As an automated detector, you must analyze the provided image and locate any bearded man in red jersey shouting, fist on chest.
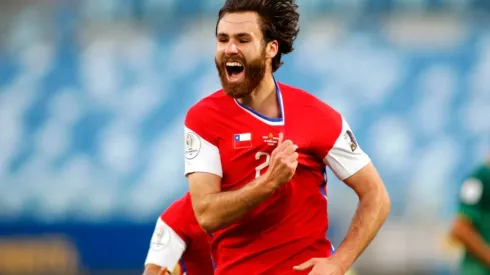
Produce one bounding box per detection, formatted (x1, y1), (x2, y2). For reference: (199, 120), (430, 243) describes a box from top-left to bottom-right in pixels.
(185, 0), (390, 275)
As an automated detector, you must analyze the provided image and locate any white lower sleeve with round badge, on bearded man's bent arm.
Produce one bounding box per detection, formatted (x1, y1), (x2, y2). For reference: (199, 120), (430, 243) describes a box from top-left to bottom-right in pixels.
(184, 127), (223, 177)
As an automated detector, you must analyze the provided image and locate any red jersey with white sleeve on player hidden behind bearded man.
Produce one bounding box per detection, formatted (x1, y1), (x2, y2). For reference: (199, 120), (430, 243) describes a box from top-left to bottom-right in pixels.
(145, 193), (214, 275)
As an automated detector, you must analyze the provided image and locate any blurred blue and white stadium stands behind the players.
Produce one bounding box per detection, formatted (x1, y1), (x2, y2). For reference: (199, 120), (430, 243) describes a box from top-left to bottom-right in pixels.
(0, 0), (490, 274)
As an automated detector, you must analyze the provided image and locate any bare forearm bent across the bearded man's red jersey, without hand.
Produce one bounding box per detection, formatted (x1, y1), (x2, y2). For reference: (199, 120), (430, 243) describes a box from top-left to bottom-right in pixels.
(196, 177), (274, 233)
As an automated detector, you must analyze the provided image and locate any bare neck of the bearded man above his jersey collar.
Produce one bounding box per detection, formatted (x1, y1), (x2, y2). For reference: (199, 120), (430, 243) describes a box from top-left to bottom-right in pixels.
(239, 74), (281, 118)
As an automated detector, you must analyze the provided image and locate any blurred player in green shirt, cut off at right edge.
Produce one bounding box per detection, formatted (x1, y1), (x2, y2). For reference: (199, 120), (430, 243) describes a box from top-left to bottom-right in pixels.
(451, 162), (490, 275)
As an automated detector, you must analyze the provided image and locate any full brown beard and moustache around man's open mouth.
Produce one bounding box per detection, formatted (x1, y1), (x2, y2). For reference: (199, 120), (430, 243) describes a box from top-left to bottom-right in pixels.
(214, 47), (266, 99)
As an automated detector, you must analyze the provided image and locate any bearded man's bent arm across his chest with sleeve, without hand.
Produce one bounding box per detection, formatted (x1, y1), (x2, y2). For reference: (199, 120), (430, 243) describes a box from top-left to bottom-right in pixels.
(184, 107), (274, 233)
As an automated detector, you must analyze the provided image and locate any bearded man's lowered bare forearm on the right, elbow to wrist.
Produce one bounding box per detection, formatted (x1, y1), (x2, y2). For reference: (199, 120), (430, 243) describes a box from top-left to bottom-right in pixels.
(332, 191), (390, 270)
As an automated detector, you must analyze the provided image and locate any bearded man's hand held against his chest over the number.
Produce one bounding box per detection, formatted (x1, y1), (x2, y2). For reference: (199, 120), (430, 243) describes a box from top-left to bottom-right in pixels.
(265, 133), (298, 189)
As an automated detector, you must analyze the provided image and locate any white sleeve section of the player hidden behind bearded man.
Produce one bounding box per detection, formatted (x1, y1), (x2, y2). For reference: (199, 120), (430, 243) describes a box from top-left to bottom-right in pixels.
(145, 218), (186, 270)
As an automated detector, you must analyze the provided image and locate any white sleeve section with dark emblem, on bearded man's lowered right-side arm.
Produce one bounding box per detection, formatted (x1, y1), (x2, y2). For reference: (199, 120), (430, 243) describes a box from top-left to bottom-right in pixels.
(323, 117), (371, 180)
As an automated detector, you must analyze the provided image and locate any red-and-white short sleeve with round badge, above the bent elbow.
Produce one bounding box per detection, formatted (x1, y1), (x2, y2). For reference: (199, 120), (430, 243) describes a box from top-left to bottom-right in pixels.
(184, 106), (223, 177)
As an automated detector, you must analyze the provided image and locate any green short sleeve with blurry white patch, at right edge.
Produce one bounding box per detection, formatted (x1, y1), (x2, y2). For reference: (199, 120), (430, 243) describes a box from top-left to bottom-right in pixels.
(459, 177), (484, 221)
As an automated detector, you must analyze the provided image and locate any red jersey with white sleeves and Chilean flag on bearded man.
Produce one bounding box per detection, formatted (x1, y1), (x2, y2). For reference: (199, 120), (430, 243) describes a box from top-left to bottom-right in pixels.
(185, 83), (370, 275)
